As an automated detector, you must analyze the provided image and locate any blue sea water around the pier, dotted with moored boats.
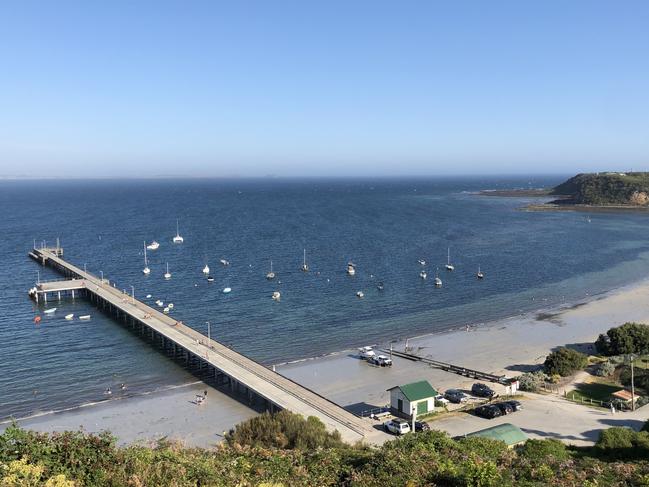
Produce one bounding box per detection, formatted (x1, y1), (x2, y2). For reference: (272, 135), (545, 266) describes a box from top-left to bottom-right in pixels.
(0, 177), (649, 418)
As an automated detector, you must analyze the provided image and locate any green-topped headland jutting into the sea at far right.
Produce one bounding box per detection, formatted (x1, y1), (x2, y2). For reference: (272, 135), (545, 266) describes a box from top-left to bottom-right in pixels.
(550, 172), (649, 207)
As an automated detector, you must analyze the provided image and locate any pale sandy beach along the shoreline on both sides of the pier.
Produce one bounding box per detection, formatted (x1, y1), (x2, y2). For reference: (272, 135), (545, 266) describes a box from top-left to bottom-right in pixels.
(7, 281), (649, 446)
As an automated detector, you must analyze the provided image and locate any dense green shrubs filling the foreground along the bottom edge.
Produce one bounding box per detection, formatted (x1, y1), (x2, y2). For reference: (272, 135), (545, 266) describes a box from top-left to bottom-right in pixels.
(0, 413), (649, 487)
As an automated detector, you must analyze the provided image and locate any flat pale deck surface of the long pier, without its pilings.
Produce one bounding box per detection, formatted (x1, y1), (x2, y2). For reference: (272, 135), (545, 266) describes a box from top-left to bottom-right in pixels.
(32, 249), (373, 442)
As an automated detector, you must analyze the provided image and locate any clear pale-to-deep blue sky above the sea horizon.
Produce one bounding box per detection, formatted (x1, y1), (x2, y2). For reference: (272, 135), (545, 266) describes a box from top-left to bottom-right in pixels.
(0, 0), (649, 176)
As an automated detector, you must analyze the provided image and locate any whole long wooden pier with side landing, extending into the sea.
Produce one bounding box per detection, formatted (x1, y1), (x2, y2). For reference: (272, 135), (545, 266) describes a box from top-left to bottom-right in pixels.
(29, 246), (372, 442)
